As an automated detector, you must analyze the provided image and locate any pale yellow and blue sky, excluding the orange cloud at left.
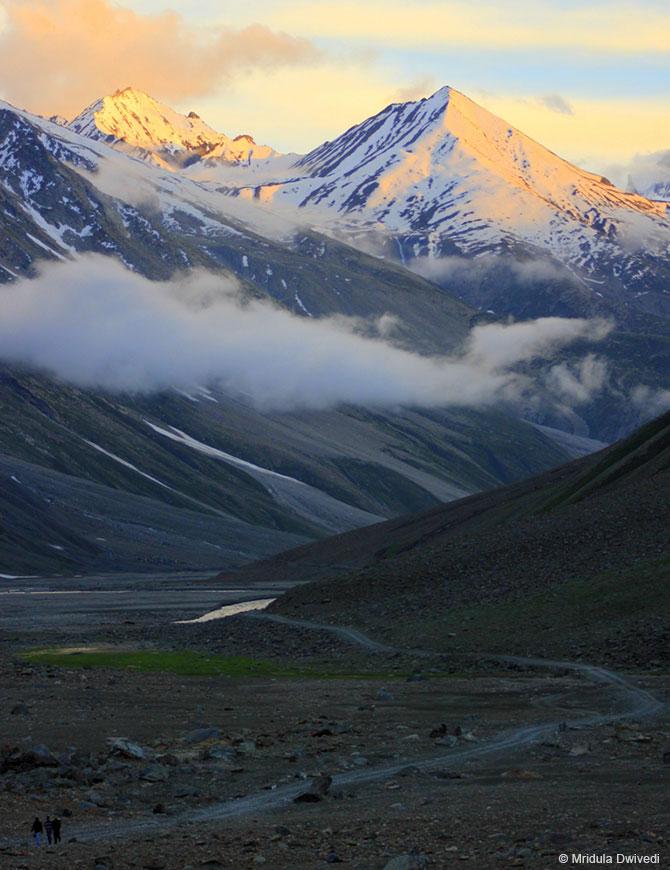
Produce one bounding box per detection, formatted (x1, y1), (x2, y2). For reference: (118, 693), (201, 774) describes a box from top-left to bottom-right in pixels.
(122, 0), (670, 169)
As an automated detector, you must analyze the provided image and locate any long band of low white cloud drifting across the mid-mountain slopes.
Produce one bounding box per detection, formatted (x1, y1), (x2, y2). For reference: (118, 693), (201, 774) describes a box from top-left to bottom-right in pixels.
(0, 255), (609, 409)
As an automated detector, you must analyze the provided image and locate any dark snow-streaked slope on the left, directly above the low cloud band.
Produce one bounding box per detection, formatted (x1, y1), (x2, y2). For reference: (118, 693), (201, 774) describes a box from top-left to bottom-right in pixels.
(0, 99), (475, 352)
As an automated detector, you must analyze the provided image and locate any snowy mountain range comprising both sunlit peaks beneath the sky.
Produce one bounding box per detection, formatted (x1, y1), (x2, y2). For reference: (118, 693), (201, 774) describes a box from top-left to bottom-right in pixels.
(8, 81), (670, 332)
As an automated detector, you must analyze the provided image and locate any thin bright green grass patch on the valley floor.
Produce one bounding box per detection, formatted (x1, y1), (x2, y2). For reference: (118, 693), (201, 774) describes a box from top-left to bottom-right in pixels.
(23, 648), (406, 680)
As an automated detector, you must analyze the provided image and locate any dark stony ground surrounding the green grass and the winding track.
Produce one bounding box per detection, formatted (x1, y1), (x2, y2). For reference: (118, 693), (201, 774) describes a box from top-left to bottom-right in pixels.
(0, 614), (670, 870)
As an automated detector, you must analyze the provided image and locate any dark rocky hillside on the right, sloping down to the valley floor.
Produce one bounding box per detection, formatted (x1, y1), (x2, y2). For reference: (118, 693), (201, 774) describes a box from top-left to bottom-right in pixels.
(231, 414), (670, 662)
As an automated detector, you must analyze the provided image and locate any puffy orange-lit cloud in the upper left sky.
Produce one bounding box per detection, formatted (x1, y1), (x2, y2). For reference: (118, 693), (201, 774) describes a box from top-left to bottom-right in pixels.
(0, 0), (319, 117)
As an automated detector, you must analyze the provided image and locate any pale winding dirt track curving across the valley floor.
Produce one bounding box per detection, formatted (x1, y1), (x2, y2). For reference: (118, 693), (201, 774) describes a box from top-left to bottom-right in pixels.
(31, 612), (665, 841)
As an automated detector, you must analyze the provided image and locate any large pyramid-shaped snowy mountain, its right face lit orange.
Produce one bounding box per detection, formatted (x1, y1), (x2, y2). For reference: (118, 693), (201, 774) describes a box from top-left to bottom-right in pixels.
(219, 87), (670, 304)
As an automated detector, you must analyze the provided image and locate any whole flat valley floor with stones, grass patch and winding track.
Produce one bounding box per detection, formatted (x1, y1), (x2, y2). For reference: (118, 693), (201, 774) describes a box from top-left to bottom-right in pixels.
(0, 575), (670, 870)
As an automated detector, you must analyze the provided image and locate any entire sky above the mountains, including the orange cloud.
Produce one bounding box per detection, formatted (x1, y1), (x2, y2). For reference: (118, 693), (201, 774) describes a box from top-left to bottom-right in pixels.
(0, 0), (670, 172)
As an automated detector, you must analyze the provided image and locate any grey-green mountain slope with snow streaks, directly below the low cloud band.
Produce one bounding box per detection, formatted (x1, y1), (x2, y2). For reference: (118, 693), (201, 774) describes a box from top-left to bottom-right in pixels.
(0, 367), (566, 574)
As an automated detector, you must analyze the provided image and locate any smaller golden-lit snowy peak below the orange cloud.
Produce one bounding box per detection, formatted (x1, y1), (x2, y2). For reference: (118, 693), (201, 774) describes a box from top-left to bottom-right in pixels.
(69, 87), (275, 168)
